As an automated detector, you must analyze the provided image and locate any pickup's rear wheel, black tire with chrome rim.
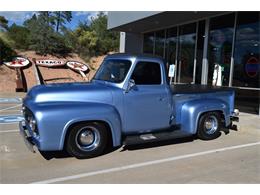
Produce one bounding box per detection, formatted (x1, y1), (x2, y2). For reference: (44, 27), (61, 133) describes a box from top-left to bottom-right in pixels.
(197, 112), (221, 140)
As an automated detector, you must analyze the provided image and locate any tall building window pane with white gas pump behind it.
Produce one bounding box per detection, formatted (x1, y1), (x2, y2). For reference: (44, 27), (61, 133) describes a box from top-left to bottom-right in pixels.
(208, 13), (235, 86)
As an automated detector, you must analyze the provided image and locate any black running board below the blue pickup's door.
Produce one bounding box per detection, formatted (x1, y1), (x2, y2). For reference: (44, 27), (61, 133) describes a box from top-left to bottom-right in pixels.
(123, 130), (187, 145)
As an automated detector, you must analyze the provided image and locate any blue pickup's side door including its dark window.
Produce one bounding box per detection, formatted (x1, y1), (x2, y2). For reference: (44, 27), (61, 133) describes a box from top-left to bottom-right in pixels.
(124, 61), (171, 133)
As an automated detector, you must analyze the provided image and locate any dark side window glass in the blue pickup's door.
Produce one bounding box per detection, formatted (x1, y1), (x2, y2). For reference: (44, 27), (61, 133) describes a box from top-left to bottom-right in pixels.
(131, 61), (162, 85)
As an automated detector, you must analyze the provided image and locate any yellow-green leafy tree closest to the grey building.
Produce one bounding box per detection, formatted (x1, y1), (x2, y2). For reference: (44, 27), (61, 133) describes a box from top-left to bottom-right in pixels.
(63, 12), (119, 60)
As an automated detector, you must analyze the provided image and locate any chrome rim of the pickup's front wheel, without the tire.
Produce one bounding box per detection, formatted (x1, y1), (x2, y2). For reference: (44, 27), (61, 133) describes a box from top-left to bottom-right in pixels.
(75, 126), (100, 151)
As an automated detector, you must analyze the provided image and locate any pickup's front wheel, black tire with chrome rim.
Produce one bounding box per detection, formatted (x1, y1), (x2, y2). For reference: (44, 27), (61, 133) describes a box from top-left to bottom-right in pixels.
(66, 122), (108, 159)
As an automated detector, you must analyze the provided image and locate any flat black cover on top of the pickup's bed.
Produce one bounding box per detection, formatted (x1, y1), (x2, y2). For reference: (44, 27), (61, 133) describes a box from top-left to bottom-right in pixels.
(170, 84), (232, 95)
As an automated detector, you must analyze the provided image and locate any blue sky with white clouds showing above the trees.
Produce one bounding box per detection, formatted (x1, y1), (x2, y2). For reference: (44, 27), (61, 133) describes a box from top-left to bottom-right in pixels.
(0, 11), (103, 30)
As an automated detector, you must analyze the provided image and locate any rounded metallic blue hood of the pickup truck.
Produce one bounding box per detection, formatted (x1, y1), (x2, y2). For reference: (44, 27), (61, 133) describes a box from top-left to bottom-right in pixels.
(26, 82), (112, 104)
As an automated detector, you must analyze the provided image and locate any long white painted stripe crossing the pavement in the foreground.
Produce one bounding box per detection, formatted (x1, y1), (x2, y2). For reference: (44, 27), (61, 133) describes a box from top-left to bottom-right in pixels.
(33, 141), (260, 184)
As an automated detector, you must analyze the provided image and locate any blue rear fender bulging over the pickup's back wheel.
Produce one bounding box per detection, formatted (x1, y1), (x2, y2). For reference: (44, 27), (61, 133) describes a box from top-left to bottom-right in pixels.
(181, 99), (230, 134)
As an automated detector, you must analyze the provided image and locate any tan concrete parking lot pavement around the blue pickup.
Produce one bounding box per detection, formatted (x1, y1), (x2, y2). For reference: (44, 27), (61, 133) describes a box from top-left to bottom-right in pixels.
(0, 93), (260, 183)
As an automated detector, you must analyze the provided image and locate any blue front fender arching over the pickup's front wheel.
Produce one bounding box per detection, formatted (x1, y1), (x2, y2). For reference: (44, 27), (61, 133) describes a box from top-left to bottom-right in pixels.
(31, 102), (121, 151)
